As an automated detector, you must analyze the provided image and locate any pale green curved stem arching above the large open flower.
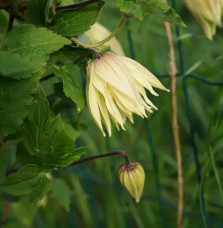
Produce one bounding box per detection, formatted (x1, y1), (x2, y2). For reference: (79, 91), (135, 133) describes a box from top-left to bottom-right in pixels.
(70, 14), (129, 48)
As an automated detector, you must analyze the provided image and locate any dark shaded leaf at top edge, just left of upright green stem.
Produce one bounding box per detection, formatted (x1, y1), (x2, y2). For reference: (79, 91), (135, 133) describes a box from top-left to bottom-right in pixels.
(25, 0), (47, 26)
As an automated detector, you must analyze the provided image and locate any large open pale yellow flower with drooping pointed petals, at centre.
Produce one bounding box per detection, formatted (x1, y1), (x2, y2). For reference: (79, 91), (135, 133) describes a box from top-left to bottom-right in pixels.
(86, 52), (168, 136)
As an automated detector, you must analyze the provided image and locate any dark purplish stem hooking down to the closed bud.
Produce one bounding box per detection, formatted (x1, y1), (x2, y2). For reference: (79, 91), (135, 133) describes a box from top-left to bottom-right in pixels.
(70, 150), (130, 166)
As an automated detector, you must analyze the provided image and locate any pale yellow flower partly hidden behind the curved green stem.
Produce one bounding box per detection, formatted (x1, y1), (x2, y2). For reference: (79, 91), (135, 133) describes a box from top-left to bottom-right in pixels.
(86, 22), (125, 56)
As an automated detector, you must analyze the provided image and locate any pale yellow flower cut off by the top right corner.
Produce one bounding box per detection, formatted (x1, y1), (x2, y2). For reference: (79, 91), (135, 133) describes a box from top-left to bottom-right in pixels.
(186, 0), (223, 40)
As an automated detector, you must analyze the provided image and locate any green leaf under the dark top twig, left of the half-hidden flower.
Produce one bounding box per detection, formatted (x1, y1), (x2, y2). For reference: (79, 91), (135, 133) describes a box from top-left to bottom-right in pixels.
(50, 1), (104, 36)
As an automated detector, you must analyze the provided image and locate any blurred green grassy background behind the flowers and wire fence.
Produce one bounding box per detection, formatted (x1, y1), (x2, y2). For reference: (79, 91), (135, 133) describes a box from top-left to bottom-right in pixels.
(0, 0), (223, 228)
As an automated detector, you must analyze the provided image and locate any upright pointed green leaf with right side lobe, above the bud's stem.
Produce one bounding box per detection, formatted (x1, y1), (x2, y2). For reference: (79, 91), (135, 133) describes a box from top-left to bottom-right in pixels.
(23, 88), (61, 157)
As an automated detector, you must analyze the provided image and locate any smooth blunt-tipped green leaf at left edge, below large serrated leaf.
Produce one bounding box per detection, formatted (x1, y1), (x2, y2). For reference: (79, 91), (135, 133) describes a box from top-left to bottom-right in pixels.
(0, 51), (38, 79)
